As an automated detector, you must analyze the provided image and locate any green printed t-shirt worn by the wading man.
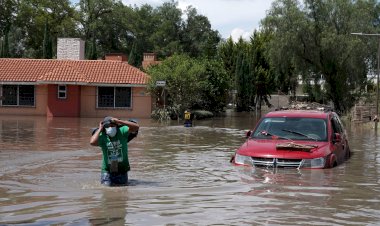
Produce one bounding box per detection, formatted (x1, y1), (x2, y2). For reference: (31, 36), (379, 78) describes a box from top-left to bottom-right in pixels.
(98, 126), (130, 174)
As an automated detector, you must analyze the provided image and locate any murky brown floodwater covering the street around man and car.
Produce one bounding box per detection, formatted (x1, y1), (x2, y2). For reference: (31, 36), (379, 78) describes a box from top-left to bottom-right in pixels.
(0, 112), (380, 225)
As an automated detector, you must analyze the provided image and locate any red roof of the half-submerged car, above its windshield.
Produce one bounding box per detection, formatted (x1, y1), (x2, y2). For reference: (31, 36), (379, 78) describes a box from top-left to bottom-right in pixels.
(265, 110), (331, 119)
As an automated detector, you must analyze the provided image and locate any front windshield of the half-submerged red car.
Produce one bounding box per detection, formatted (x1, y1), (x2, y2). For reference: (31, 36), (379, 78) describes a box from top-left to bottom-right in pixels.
(252, 117), (327, 141)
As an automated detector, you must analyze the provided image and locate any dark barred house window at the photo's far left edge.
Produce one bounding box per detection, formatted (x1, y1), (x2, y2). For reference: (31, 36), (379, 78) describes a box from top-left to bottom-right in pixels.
(2, 85), (35, 106)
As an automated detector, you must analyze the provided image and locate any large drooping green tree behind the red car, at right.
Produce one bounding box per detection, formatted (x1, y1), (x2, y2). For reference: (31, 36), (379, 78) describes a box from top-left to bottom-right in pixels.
(263, 0), (378, 112)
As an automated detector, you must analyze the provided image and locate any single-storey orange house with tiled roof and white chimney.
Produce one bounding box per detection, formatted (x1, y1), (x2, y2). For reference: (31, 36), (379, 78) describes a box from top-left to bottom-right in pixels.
(0, 39), (156, 118)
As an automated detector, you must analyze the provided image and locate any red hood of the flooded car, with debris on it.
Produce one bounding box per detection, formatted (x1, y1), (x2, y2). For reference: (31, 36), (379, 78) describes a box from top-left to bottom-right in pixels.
(237, 139), (329, 159)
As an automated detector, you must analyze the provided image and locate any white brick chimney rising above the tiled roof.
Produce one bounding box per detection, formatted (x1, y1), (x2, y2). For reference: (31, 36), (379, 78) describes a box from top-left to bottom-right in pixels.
(57, 38), (84, 60)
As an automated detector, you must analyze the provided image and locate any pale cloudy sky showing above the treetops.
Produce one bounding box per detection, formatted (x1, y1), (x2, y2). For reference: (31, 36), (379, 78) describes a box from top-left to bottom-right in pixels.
(123, 0), (274, 40)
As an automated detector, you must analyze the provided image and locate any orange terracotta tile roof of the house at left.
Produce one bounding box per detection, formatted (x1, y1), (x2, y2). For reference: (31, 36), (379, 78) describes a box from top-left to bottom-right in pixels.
(0, 58), (148, 85)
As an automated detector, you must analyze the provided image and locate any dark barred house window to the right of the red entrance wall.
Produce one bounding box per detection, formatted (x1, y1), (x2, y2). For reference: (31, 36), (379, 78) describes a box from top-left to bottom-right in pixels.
(98, 87), (132, 108)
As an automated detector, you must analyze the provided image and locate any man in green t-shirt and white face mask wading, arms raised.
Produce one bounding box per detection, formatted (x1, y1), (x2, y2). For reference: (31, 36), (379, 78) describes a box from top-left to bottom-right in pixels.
(90, 117), (139, 186)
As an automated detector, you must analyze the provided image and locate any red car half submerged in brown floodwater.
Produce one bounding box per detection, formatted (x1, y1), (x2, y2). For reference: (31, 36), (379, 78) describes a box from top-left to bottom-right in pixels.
(231, 110), (350, 169)
